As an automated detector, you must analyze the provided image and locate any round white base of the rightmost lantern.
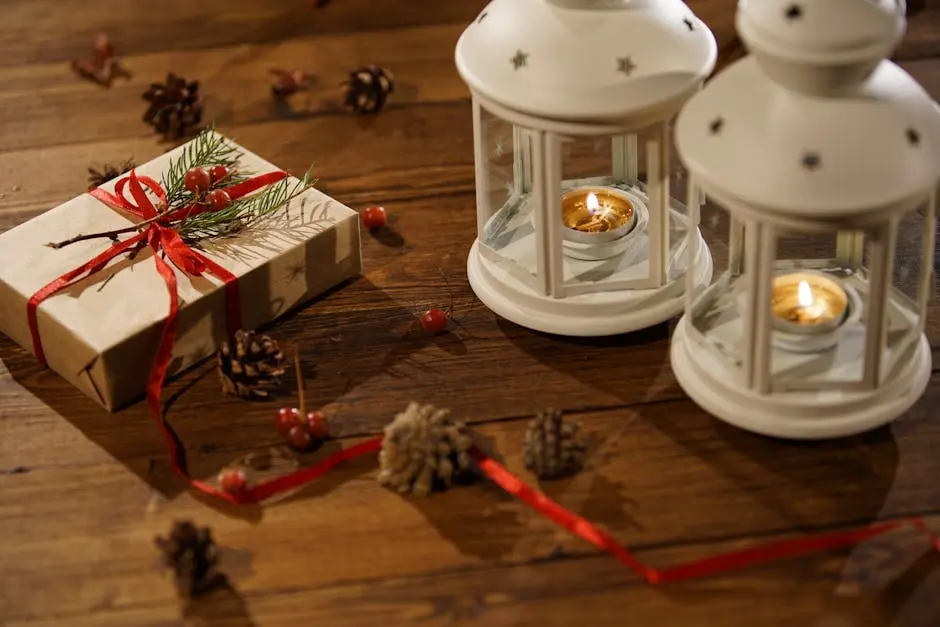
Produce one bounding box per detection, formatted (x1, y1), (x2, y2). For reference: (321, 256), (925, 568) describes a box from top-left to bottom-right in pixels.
(670, 316), (931, 440)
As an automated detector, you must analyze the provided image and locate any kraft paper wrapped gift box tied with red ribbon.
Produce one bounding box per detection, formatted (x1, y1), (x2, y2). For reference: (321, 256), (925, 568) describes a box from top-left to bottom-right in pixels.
(0, 132), (362, 411)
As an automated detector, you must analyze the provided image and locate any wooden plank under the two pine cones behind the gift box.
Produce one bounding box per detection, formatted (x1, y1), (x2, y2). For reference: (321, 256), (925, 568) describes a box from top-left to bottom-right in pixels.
(0, 23), (469, 151)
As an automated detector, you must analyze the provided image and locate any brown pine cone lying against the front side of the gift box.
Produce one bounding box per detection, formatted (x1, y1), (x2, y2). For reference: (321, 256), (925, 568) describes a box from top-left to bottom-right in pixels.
(217, 331), (284, 399)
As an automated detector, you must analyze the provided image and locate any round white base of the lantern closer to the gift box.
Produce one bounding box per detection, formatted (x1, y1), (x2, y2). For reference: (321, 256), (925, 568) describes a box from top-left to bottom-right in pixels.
(467, 233), (713, 337)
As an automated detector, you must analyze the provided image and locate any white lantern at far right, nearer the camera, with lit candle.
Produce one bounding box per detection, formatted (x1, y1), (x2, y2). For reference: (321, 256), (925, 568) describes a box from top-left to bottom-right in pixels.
(671, 0), (940, 439)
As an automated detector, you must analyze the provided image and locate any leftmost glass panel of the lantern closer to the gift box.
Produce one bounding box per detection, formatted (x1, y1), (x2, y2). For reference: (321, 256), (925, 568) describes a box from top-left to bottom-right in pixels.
(477, 107), (540, 285)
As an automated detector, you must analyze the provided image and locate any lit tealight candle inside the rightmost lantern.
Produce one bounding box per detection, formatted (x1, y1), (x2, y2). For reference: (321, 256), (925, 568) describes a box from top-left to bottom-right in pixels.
(771, 272), (849, 334)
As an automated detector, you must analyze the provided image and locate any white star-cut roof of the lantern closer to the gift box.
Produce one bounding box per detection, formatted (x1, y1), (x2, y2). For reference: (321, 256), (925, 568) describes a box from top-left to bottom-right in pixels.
(455, 0), (717, 121)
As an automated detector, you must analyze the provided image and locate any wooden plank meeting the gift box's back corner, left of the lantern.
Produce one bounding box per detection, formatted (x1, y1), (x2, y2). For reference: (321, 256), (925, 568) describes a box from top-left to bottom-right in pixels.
(0, 101), (474, 230)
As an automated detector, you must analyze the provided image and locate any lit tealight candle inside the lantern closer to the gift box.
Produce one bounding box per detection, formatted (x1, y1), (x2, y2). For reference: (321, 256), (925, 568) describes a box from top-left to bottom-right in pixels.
(561, 187), (636, 244)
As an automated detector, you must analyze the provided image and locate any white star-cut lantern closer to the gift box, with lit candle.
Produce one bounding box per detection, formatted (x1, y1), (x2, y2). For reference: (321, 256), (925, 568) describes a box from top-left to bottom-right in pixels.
(456, 0), (717, 336)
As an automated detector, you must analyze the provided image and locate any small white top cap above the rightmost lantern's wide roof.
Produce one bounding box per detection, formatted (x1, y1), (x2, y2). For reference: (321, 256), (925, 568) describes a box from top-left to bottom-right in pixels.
(736, 0), (906, 58)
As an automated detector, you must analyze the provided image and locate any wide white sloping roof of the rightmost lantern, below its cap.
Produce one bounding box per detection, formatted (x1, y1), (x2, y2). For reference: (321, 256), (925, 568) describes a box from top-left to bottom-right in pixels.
(676, 56), (940, 217)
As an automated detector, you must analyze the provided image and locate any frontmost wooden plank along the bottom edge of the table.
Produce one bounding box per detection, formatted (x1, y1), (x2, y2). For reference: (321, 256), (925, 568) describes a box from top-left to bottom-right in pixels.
(10, 524), (940, 627)
